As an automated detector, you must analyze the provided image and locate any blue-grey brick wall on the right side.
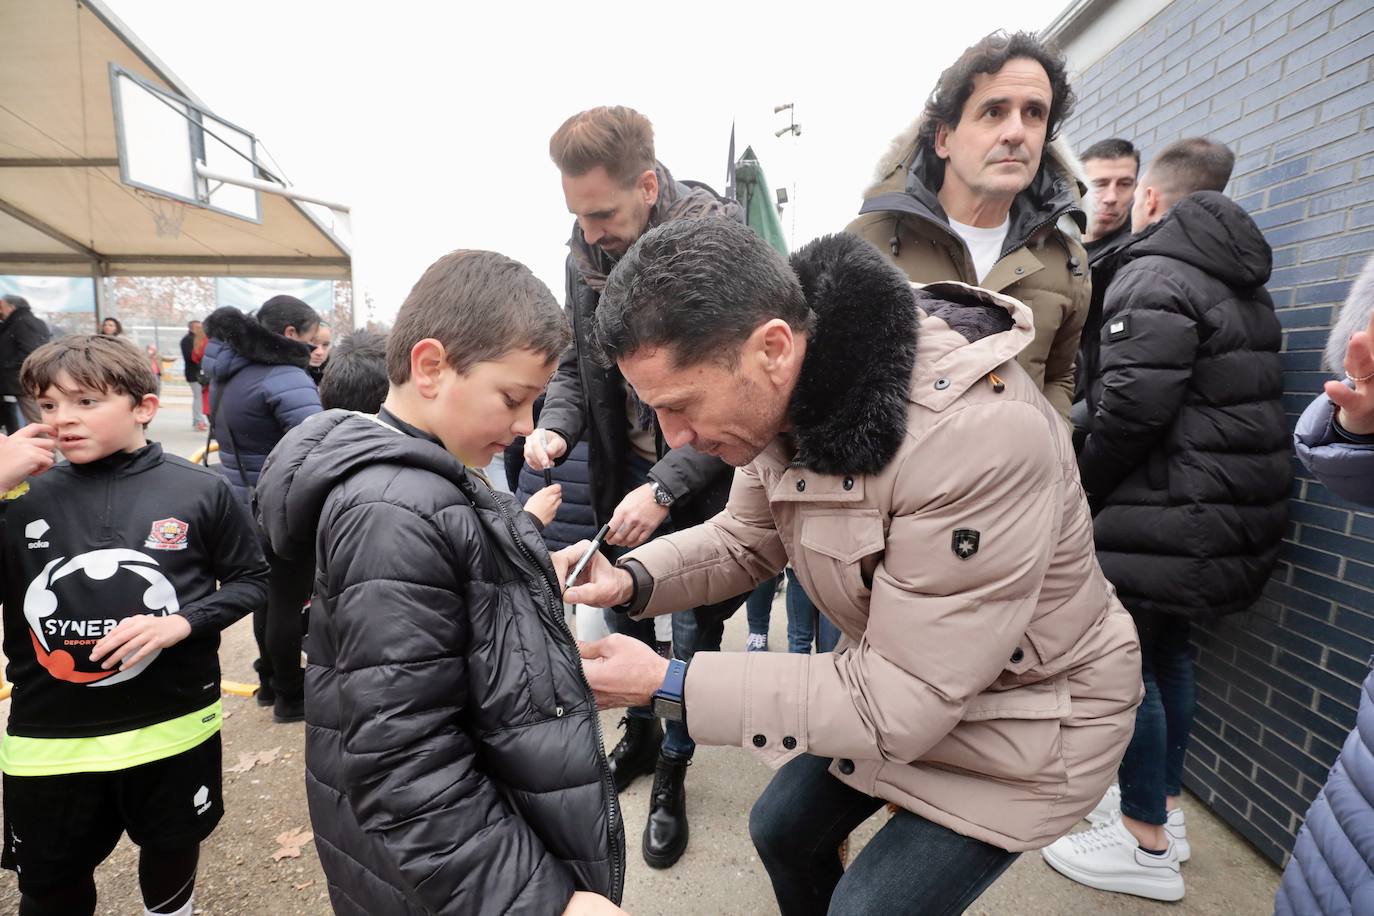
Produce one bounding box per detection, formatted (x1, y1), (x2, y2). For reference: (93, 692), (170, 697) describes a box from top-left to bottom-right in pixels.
(1068, 0), (1374, 862)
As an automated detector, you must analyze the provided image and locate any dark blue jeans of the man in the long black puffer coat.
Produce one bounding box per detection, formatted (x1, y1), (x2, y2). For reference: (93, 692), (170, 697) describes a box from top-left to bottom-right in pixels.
(1117, 614), (1198, 824)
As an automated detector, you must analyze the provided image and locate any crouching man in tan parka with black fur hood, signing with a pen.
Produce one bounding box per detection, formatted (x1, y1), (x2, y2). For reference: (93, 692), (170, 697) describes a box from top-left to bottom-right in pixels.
(554, 218), (1143, 916)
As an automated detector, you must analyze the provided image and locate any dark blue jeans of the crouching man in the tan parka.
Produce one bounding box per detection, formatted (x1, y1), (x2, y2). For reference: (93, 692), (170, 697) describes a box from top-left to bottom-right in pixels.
(749, 754), (1017, 916)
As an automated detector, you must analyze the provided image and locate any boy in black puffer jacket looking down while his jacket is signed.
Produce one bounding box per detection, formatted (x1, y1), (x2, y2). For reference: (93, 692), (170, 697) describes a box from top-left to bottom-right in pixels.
(257, 251), (625, 915)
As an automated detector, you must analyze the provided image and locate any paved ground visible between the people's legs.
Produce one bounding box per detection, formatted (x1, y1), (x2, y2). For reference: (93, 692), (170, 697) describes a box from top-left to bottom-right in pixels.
(0, 385), (1278, 916)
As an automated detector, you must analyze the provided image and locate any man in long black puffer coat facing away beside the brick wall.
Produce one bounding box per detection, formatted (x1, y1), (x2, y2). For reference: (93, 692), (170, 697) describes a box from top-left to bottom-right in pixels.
(1044, 137), (1293, 901)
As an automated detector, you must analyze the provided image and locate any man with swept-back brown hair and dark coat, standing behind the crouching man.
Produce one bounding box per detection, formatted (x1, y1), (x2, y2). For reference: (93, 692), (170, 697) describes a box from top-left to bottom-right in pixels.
(525, 106), (752, 868)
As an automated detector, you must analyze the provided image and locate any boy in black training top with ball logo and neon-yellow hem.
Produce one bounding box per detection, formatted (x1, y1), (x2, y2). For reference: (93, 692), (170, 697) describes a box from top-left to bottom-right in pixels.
(0, 335), (267, 916)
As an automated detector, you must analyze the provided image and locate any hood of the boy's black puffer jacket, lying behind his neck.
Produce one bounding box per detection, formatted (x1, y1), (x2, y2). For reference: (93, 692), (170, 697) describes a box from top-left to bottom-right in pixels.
(257, 411), (478, 559)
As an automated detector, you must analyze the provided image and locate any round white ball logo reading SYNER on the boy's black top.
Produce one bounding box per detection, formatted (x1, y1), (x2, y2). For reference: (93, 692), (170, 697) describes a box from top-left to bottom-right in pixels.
(23, 548), (181, 687)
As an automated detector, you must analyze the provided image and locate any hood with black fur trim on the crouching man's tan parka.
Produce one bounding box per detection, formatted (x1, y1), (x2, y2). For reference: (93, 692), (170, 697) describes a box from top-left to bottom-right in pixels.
(787, 232), (1013, 474)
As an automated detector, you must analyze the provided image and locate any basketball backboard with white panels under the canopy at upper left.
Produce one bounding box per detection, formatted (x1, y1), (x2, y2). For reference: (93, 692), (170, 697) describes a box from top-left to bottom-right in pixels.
(110, 63), (262, 223)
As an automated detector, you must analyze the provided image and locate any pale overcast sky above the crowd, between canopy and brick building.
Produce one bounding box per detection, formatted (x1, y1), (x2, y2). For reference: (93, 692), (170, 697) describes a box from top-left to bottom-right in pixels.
(107, 0), (1066, 319)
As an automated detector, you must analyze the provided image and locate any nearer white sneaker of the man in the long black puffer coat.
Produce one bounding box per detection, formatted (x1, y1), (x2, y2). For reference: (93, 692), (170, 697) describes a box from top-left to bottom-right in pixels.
(1040, 818), (1183, 901)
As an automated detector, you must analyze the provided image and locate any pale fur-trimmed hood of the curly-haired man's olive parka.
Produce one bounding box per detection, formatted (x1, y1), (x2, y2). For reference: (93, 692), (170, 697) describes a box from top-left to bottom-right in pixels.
(860, 117), (1092, 240)
